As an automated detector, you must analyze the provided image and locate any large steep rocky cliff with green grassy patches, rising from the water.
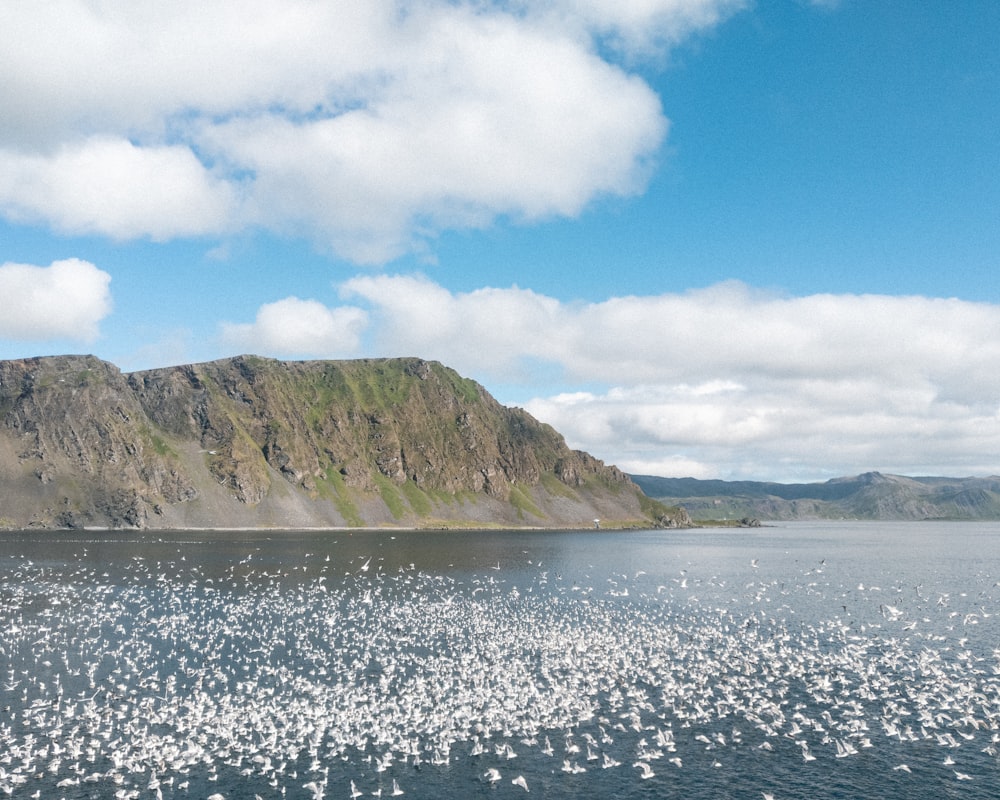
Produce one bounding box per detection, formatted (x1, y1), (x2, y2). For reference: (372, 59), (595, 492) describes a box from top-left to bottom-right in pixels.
(0, 356), (687, 528)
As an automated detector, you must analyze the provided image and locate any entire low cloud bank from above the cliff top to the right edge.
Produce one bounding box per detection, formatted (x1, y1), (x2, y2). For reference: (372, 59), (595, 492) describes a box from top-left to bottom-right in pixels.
(233, 275), (1000, 480)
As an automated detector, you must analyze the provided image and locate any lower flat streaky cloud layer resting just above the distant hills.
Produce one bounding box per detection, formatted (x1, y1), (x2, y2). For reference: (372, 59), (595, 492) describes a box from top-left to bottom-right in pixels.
(526, 380), (1000, 480)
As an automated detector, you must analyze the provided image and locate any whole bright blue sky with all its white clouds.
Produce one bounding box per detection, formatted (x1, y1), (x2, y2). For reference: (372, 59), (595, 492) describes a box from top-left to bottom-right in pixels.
(0, 0), (1000, 482)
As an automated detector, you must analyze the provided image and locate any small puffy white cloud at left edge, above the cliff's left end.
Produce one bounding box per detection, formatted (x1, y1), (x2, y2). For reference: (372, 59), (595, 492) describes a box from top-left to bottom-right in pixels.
(0, 258), (111, 342)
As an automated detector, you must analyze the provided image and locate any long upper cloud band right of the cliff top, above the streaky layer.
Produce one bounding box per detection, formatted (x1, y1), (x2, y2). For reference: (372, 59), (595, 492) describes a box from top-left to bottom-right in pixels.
(341, 275), (1000, 390)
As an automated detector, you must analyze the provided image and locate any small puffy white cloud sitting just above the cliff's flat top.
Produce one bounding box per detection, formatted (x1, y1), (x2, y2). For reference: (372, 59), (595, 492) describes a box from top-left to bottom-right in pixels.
(222, 297), (368, 358)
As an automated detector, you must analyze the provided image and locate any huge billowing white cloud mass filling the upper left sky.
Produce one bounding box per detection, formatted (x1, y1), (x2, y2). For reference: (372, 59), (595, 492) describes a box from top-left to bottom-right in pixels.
(0, 0), (740, 262)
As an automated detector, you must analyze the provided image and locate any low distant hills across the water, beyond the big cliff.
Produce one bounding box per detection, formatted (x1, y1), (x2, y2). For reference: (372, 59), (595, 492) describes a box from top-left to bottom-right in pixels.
(631, 472), (1000, 520)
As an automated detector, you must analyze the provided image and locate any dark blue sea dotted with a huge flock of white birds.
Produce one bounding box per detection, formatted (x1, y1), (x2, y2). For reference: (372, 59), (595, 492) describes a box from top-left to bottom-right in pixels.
(0, 521), (1000, 800)
